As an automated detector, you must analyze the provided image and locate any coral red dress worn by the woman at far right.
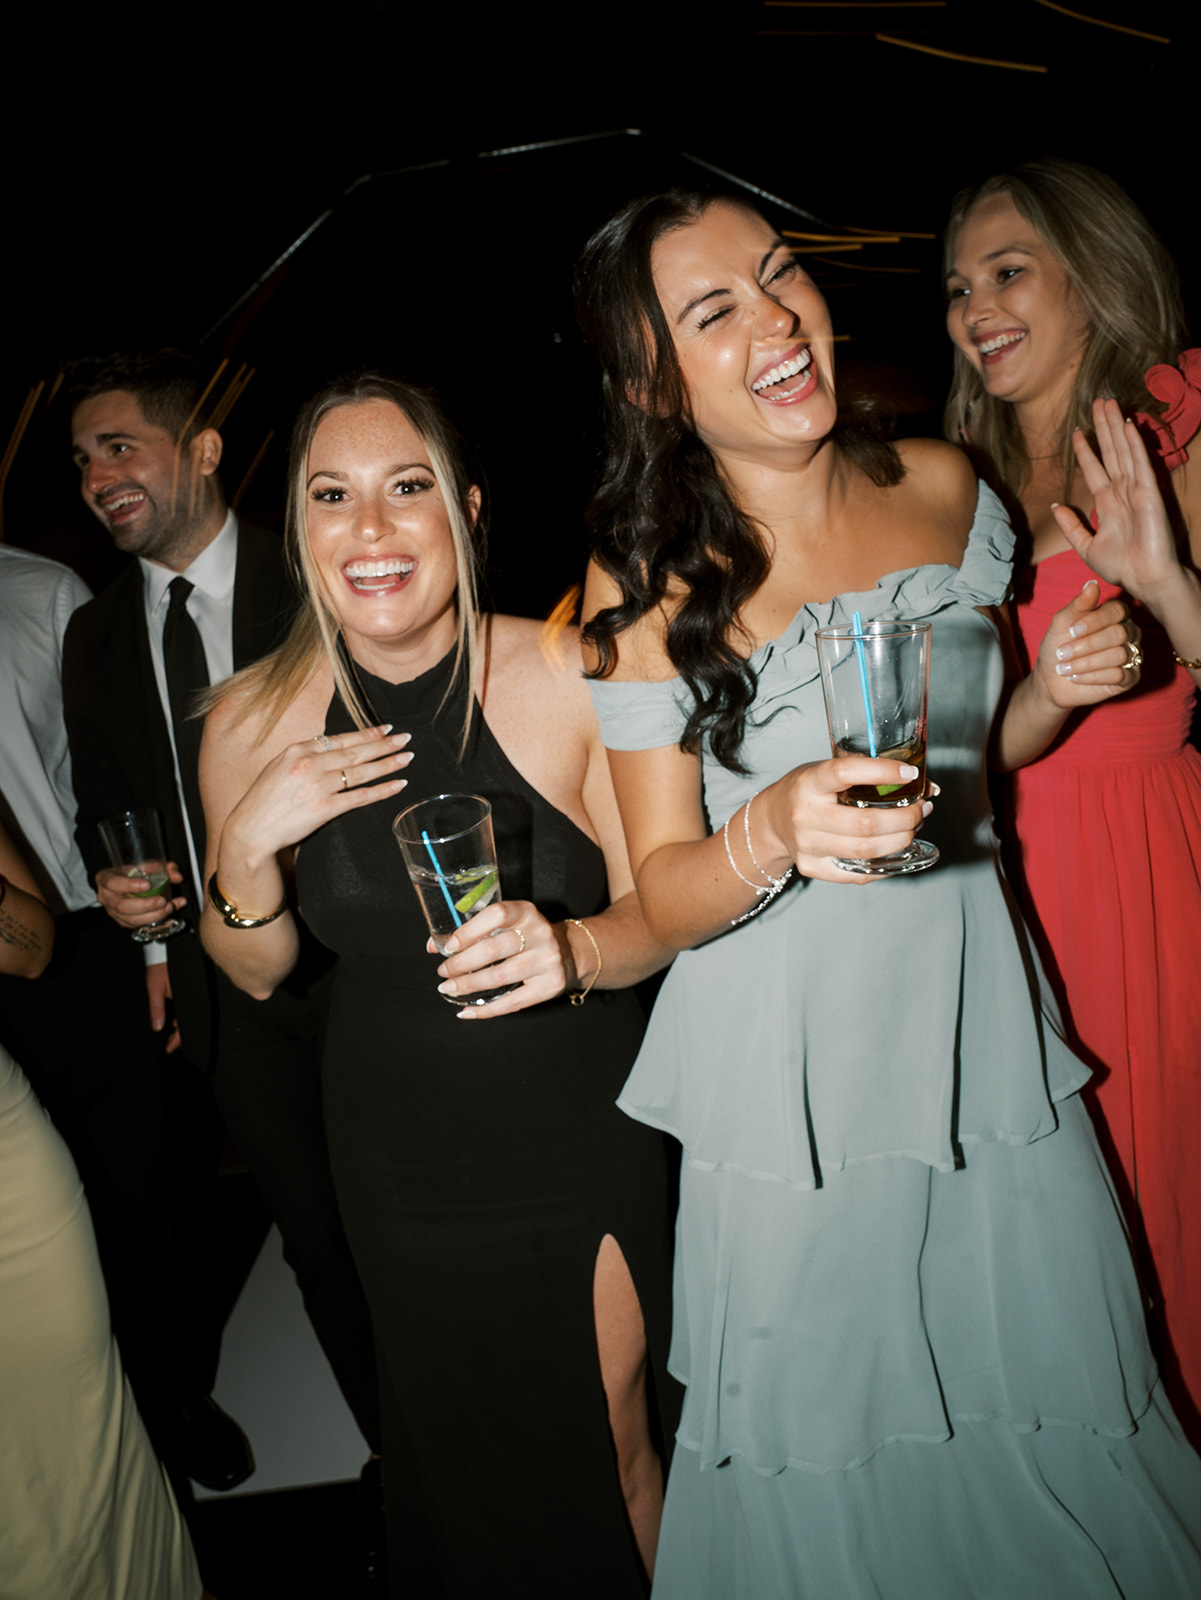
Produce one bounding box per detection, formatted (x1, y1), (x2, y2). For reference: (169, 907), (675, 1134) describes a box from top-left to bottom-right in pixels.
(1012, 368), (1201, 1442)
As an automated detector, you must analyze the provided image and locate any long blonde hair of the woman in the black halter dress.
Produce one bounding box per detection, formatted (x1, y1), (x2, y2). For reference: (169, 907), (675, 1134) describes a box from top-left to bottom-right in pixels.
(215, 371), (483, 746)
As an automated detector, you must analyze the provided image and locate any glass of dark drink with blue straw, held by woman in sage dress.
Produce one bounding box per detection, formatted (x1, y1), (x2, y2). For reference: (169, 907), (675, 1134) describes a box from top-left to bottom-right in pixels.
(817, 622), (939, 877)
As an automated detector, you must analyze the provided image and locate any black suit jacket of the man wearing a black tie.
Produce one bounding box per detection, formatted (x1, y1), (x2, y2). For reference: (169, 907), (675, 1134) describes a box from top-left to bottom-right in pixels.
(62, 522), (296, 1070)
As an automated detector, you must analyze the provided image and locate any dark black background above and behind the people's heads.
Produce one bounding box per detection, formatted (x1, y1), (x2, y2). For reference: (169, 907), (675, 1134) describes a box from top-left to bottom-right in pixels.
(0, 0), (1196, 614)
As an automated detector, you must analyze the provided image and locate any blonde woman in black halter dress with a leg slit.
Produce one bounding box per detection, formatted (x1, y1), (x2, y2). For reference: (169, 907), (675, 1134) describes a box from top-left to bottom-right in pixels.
(201, 378), (681, 1600)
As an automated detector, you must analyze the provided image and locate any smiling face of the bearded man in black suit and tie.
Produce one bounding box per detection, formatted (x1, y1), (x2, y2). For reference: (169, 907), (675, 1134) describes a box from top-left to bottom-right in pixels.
(70, 389), (225, 573)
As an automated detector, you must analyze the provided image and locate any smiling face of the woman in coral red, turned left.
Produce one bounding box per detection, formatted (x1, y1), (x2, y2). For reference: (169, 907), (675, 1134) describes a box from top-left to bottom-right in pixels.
(947, 194), (1089, 416)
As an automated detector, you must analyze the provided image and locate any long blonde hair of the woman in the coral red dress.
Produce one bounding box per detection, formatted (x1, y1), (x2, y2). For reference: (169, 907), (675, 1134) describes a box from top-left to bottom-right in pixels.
(944, 157), (1185, 499)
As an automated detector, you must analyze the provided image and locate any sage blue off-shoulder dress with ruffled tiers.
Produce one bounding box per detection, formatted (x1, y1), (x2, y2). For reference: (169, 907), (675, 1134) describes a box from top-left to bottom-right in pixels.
(593, 486), (1201, 1600)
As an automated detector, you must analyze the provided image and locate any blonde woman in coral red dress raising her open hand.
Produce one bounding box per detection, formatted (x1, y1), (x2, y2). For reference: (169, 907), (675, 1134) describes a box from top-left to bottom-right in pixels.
(947, 160), (1201, 1442)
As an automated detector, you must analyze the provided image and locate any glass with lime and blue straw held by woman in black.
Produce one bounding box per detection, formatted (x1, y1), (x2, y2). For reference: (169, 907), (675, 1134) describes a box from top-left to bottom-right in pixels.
(392, 795), (520, 1005)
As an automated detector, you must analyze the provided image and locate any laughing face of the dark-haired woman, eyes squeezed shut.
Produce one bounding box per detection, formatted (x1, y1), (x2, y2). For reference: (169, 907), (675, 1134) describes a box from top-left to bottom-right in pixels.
(651, 202), (836, 470)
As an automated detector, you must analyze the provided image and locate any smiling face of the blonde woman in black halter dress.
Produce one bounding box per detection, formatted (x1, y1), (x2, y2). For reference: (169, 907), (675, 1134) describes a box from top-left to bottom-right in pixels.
(304, 400), (480, 682)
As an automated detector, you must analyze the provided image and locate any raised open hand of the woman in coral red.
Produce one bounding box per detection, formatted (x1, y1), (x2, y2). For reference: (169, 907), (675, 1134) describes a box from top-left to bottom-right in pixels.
(1052, 400), (1180, 603)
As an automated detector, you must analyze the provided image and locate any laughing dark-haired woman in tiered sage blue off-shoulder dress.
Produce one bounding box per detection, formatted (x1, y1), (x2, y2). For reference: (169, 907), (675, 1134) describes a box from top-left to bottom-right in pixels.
(577, 194), (1201, 1600)
